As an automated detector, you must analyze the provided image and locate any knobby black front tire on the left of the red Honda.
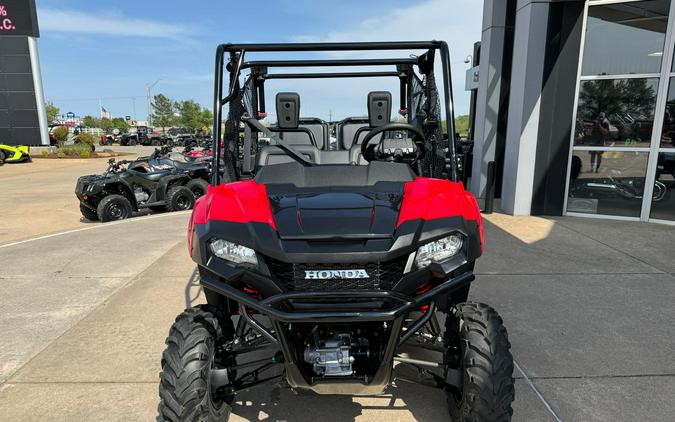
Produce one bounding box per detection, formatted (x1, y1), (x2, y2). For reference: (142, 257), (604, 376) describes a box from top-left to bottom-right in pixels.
(158, 305), (234, 422)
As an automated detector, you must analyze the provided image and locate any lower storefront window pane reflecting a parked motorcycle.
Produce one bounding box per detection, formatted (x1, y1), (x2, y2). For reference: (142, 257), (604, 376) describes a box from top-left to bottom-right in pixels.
(567, 150), (649, 217)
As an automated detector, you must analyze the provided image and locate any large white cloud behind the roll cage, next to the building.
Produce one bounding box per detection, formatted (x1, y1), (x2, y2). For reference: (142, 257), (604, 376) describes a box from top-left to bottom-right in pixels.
(282, 0), (483, 117)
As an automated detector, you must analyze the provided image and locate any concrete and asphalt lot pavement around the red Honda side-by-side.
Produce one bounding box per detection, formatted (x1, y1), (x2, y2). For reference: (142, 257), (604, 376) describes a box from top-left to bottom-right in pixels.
(0, 156), (675, 421)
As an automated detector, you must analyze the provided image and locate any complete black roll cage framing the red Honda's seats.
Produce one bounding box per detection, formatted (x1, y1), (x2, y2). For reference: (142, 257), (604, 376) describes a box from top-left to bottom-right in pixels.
(212, 41), (458, 186)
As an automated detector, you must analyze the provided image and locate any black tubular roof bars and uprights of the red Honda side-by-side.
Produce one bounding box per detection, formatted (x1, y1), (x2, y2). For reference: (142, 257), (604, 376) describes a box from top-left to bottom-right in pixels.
(213, 41), (458, 185)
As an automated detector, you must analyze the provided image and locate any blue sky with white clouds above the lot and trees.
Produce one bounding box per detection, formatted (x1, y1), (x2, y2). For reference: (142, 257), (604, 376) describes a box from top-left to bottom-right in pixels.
(37, 0), (483, 120)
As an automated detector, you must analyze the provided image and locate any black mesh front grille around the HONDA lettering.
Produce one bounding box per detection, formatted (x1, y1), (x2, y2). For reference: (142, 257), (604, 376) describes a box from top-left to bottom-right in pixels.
(265, 256), (408, 292)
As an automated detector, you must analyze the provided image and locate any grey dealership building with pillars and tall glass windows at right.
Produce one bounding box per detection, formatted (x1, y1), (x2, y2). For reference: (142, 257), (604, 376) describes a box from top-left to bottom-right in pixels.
(471, 0), (675, 224)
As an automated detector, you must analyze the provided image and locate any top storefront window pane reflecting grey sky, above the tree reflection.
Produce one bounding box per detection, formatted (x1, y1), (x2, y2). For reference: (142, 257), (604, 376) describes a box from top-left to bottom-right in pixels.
(581, 0), (670, 76)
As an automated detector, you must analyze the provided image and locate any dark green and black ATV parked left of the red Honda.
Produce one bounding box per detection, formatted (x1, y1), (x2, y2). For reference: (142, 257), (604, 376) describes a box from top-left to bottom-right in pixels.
(75, 158), (195, 222)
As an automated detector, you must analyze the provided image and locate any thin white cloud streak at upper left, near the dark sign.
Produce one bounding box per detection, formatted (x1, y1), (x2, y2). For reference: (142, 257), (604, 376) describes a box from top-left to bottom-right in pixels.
(38, 7), (188, 39)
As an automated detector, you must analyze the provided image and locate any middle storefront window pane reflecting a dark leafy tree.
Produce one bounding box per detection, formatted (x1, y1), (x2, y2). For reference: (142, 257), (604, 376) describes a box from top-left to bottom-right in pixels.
(574, 78), (658, 148)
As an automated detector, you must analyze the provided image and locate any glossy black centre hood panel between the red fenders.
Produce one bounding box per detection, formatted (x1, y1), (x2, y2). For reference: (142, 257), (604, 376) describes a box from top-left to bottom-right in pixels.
(268, 182), (403, 240)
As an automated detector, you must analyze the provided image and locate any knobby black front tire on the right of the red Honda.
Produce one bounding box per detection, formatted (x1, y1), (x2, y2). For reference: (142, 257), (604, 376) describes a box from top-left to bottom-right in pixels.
(445, 302), (515, 422)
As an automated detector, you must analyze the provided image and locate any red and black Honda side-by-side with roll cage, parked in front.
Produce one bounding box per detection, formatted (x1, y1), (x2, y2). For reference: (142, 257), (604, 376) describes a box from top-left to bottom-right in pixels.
(159, 41), (514, 421)
